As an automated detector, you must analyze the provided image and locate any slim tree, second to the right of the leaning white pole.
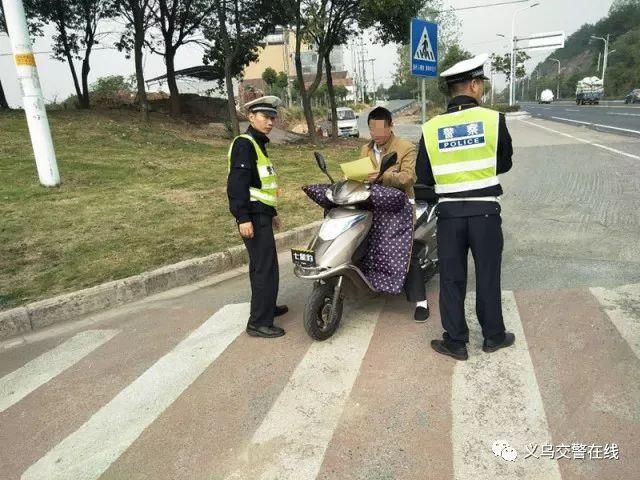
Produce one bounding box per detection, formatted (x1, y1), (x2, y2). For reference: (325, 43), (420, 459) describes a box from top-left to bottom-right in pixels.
(114, 0), (157, 122)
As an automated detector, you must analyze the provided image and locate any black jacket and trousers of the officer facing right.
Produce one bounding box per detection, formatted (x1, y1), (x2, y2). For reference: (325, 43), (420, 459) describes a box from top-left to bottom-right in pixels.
(227, 126), (280, 327)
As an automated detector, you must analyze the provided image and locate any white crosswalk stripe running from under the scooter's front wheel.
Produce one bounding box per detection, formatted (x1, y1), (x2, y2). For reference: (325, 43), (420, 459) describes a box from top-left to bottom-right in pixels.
(228, 301), (382, 480)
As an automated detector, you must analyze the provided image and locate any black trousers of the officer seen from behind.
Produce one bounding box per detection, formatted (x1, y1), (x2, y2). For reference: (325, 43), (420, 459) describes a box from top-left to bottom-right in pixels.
(437, 214), (505, 342)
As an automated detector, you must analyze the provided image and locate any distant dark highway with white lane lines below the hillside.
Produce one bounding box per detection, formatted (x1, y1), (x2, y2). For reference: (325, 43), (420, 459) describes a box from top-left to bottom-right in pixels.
(522, 102), (640, 136)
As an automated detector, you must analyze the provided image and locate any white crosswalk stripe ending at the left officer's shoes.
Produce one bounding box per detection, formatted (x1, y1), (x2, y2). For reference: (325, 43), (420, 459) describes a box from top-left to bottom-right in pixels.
(22, 304), (249, 480)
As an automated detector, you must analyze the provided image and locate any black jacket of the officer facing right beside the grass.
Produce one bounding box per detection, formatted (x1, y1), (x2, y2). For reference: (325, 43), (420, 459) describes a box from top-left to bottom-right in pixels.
(227, 126), (278, 223)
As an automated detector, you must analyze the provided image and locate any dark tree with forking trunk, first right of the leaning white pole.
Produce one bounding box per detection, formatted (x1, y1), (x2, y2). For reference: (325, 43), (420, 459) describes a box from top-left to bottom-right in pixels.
(29, 0), (115, 108)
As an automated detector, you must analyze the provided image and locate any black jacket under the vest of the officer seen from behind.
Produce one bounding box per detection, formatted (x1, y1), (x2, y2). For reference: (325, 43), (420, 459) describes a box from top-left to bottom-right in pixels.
(416, 95), (513, 216)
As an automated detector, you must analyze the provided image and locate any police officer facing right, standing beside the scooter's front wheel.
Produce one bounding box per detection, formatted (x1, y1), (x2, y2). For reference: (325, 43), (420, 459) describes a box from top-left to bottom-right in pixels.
(227, 96), (289, 338)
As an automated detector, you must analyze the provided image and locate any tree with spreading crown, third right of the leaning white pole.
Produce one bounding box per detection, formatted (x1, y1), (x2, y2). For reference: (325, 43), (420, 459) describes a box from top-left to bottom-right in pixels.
(147, 0), (219, 116)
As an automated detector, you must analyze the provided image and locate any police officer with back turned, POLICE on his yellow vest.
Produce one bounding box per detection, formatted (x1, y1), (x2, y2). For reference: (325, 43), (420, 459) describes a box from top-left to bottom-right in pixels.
(416, 54), (515, 360)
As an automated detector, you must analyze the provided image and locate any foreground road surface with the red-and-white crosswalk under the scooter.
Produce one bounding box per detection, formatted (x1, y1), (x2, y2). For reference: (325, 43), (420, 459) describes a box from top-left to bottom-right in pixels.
(0, 117), (640, 480)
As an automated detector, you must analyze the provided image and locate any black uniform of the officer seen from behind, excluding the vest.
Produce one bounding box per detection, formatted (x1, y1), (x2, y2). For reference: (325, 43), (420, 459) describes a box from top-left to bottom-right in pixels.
(416, 95), (513, 345)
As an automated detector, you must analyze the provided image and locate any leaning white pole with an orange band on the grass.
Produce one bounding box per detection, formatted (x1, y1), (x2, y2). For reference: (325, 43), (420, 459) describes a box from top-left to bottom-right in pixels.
(3, 0), (60, 187)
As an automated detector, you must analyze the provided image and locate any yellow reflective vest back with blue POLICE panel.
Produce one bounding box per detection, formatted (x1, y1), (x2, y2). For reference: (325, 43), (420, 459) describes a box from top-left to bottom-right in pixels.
(422, 107), (500, 195)
